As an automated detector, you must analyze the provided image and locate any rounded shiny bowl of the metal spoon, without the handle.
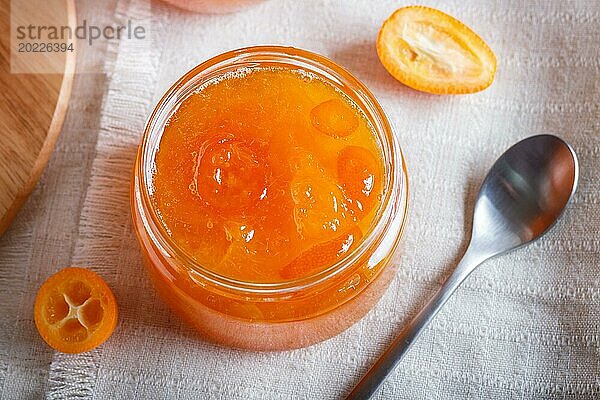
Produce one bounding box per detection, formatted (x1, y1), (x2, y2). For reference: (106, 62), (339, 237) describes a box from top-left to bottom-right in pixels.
(471, 135), (579, 257)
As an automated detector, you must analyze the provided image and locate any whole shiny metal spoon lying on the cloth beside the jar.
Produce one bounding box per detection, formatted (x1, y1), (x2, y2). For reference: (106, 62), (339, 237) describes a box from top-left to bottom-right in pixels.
(347, 135), (579, 400)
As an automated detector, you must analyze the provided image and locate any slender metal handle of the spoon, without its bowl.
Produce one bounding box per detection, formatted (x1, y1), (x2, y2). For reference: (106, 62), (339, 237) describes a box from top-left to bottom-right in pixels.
(346, 249), (484, 400)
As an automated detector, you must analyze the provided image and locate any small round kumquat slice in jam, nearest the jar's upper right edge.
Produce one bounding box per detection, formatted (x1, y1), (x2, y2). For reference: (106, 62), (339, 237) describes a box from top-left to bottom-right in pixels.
(310, 99), (359, 137)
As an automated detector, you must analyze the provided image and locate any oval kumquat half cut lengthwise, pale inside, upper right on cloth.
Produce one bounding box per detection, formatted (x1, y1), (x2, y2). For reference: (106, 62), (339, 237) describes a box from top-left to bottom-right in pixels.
(377, 6), (496, 94)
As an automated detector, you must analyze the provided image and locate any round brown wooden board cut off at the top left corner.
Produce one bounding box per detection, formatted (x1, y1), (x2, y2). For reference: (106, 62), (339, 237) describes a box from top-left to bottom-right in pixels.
(0, 0), (76, 235)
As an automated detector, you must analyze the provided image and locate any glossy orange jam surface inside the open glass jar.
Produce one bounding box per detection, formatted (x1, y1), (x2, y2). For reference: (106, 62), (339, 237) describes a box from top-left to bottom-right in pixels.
(151, 67), (384, 283)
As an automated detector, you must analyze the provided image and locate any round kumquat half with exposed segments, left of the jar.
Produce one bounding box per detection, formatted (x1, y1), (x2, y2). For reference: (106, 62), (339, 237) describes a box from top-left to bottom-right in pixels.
(33, 267), (117, 353)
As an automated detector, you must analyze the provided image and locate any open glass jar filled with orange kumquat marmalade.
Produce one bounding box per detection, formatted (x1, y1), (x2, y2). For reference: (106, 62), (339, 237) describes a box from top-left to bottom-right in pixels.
(131, 46), (408, 350)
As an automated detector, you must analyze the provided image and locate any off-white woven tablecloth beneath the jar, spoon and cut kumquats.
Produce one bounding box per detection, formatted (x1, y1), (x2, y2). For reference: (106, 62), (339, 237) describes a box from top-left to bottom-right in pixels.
(0, 0), (600, 399)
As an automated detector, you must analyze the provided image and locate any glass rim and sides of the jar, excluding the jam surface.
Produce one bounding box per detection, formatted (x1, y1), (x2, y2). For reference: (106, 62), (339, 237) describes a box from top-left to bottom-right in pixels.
(131, 46), (408, 350)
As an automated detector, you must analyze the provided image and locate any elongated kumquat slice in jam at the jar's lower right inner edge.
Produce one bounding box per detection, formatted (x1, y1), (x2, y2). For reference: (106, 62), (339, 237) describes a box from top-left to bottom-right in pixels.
(280, 227), (362, 279)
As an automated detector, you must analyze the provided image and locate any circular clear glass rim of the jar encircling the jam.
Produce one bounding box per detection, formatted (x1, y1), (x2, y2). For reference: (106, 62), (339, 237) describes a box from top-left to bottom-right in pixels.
(134, 46), (407, 294)
